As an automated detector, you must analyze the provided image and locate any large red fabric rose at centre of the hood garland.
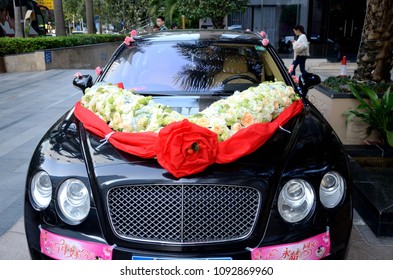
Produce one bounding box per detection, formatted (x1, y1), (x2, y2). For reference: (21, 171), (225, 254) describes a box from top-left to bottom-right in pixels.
(155, 120), (218, 178)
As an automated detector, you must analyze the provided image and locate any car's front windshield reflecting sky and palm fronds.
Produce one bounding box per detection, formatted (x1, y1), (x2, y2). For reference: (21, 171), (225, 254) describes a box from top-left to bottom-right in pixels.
(102, 41), (284, 95)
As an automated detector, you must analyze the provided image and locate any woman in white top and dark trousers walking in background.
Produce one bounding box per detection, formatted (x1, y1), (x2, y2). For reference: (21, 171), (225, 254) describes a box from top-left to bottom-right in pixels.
(288, 25), (310, 76)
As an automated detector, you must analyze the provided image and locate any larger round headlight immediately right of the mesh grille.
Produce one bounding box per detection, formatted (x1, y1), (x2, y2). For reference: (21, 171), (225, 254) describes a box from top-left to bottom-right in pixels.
(278, 179), (314, 223)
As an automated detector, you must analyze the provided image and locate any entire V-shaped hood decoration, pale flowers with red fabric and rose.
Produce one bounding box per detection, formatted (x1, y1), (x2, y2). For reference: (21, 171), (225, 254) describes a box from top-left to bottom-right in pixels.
(74, 82), (303, 178)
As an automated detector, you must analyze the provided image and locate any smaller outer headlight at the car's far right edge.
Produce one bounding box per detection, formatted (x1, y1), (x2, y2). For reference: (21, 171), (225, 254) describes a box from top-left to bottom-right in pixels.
(319, 171), (345, 208)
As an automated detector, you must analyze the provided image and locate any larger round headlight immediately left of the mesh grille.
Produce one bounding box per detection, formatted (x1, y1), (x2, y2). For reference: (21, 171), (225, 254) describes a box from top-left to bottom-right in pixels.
(57, 179), (90, 225)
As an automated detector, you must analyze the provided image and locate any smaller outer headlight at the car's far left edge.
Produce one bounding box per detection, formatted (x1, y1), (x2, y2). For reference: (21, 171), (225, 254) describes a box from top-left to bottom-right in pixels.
(30, 171), (52, 210)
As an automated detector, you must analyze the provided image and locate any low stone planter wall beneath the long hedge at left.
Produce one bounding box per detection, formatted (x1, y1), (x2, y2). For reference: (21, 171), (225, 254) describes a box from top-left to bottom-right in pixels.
(0, 42), (121, 72)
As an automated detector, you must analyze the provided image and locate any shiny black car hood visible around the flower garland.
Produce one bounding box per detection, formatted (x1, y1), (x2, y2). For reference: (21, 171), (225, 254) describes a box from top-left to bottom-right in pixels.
(77, 96), (302, 185)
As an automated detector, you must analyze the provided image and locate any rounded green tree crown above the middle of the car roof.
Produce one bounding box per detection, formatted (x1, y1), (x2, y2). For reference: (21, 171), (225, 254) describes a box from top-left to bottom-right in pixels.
(177, 0), (249, 29)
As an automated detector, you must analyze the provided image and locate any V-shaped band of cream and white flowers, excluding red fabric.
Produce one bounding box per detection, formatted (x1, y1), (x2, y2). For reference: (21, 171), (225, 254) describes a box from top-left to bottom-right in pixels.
(81, 82), (299, 142)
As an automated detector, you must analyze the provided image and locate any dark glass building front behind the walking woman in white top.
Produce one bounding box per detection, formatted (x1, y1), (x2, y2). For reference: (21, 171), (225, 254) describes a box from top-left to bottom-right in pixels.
(228, 0), (367, 60)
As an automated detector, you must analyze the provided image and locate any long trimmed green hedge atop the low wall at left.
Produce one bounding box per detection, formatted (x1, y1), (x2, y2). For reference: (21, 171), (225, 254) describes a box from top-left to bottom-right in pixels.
(0, 34), (125, 55)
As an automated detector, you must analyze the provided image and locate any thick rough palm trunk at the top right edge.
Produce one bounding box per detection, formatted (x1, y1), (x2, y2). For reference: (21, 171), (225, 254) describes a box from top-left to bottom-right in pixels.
(354, 0), (393, 82)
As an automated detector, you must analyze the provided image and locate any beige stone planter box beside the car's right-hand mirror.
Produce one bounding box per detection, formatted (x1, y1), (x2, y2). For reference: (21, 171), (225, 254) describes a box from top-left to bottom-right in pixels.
(307, 85), (378, 145)
